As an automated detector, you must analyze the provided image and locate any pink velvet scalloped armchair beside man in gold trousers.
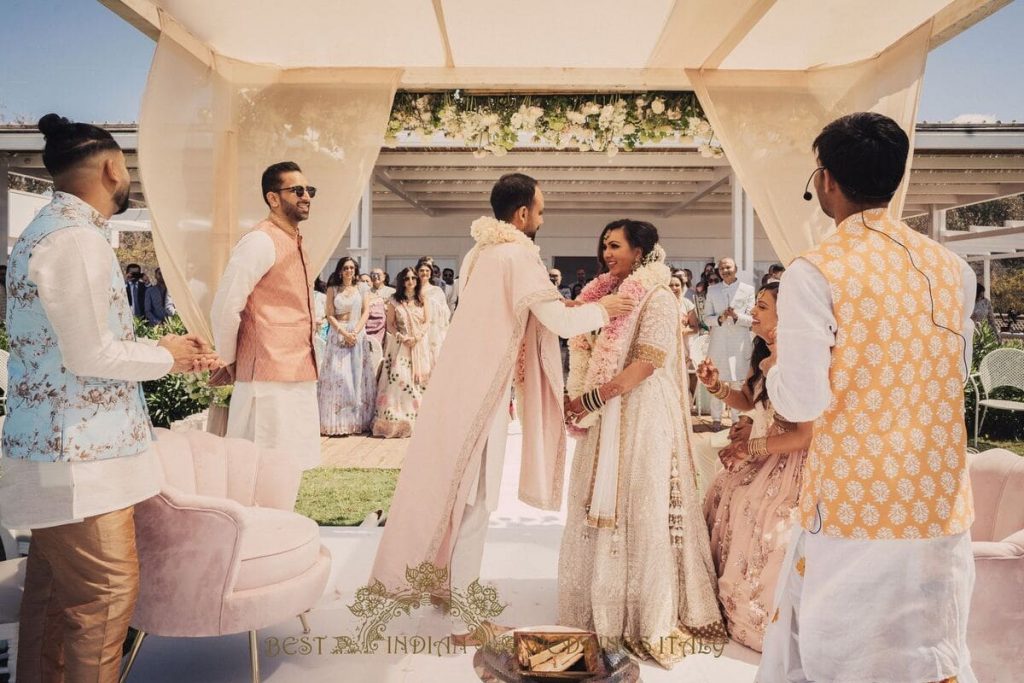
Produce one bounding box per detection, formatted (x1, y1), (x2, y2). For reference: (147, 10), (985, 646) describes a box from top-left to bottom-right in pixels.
(121, 429), (331, 682)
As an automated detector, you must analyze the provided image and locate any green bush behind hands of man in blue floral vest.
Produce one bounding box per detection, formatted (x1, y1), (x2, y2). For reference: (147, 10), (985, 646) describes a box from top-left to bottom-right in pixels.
(135, 315), (231, 427)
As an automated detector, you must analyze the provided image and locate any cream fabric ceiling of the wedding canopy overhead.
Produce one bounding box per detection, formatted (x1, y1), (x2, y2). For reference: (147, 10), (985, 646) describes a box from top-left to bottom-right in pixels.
(99, 0), (1010, 92)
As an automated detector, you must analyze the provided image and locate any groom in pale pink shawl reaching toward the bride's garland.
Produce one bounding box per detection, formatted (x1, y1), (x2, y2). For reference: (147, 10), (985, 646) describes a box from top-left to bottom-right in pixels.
(373, 173), (633, 643)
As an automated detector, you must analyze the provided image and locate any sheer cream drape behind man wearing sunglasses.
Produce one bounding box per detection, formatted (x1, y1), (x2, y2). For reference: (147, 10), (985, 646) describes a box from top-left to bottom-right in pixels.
(138, 14), (401, 339)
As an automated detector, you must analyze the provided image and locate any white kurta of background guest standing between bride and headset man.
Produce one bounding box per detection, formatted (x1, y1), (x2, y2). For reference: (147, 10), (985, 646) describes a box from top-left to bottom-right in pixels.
(705, 280), (756, 382)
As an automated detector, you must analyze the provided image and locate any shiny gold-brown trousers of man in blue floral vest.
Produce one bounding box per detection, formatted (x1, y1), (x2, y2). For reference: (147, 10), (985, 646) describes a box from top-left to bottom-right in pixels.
(17, 507), (138, 683)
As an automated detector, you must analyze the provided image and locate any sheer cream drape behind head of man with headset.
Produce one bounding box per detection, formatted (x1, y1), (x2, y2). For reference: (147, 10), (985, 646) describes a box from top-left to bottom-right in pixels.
(687, 22), (932, 263)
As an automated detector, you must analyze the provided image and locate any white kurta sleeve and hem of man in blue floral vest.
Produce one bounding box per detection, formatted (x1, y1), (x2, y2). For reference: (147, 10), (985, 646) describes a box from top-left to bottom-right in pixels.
(0, 220), (174, 528)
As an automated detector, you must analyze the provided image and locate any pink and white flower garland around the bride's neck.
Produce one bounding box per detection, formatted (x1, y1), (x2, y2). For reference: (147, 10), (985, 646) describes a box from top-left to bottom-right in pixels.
(566, 245), (672, 438)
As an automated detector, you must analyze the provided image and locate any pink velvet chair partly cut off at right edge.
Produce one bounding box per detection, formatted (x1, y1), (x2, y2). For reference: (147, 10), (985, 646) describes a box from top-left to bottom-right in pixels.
(967, 449), (1024, 683)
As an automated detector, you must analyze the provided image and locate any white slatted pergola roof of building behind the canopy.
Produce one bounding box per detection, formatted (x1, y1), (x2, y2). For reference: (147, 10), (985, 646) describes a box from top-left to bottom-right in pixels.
(0, 124), (1024, 216)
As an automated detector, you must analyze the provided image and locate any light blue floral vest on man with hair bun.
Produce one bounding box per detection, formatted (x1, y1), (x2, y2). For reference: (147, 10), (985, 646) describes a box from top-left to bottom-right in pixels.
(3, 193), (153, 462)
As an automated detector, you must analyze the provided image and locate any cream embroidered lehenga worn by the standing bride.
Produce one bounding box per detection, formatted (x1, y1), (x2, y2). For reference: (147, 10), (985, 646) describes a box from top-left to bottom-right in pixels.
(558, 276), (726, 668)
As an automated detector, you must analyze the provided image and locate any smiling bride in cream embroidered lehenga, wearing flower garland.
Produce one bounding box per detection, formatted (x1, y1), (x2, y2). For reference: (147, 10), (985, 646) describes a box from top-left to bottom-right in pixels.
(558, 220), (727, 668)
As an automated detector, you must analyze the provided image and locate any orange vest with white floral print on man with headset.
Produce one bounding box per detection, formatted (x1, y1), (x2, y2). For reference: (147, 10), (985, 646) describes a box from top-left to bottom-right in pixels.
(800, 209), (974, 539)
